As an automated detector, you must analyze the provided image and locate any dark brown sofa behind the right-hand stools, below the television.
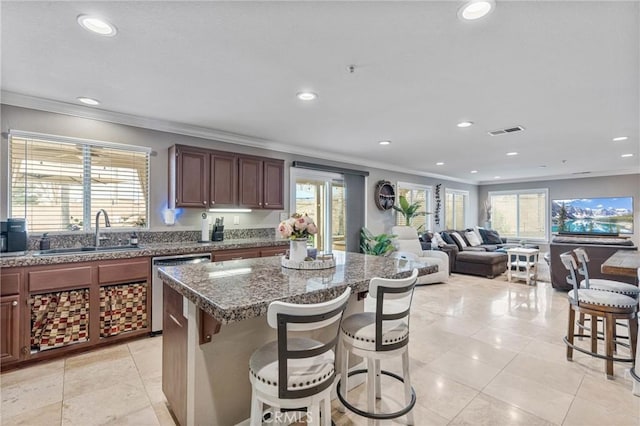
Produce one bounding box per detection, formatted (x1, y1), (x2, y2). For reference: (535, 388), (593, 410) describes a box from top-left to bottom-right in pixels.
(549, 235), (638, 290)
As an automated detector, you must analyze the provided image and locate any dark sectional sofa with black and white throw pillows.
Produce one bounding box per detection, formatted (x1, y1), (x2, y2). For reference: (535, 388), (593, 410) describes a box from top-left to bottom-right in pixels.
(421, 228), (518, 278)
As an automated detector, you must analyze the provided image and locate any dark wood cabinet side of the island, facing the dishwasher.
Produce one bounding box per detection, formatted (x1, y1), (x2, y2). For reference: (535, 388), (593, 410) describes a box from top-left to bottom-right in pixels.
(162, 284), (188, 426)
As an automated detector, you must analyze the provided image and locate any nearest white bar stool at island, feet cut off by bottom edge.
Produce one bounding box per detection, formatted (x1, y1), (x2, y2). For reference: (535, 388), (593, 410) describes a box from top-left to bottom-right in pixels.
(249, 288), (351, 426)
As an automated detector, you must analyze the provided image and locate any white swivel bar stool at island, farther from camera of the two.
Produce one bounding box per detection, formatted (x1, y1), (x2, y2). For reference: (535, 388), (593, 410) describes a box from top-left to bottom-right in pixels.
(337, 269), (418, 424)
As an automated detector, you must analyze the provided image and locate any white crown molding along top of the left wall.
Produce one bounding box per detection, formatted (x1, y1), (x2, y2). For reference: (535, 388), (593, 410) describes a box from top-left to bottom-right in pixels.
(0, 90), (478, 185)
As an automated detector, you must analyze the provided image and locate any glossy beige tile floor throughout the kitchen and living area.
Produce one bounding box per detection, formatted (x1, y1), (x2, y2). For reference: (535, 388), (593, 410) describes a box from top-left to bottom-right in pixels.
(0, 275), (640, 426)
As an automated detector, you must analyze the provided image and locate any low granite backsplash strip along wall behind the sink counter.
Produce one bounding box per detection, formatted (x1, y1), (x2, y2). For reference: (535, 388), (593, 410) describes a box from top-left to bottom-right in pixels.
(29, 228), (276, 250)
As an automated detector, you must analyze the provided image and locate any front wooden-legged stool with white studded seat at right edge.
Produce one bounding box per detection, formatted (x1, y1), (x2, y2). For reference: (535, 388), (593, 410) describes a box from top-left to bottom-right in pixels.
(560, 252), (638, 379)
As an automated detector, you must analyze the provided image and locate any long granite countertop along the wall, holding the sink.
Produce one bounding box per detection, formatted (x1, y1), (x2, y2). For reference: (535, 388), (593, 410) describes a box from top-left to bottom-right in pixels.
(0, 238), (289, 268)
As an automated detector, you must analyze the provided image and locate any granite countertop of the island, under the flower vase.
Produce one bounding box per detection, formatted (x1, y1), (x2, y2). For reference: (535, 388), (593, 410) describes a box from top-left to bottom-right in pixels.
(159, 252), (438, 324)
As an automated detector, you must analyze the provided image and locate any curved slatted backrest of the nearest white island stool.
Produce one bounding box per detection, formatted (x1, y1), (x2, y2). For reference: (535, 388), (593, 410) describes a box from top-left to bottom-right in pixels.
(267, 287), (351, 399)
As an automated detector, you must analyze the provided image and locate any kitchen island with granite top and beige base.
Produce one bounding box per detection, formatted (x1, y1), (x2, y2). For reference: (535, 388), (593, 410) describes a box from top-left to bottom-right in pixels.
(159, 253), (437, 425)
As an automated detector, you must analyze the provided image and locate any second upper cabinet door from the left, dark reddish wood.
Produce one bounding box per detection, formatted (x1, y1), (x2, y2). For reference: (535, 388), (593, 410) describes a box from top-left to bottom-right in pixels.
(209, 153), (238, 207)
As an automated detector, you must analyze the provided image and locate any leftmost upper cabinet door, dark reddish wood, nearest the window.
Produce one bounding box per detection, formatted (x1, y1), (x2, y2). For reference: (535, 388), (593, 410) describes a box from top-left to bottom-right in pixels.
(175, 148), (209, 207)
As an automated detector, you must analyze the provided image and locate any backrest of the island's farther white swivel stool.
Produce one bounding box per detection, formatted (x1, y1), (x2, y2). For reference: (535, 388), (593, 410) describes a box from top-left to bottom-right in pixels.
(369, 269), (418, 351)
